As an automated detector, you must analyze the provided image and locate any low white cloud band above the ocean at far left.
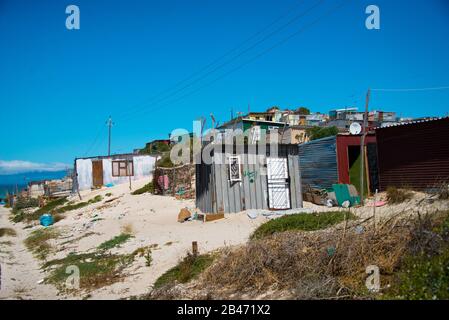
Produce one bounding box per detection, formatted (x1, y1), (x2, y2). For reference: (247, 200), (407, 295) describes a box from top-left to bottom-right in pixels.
(0, 160), (70, 175)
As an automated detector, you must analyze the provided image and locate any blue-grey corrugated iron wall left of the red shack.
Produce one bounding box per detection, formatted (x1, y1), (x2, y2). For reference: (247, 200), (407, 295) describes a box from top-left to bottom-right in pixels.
(299, 136), (338, 189)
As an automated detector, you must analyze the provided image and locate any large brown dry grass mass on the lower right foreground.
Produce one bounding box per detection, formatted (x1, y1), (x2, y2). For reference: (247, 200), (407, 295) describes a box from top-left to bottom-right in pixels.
(188, 213), (447, 299)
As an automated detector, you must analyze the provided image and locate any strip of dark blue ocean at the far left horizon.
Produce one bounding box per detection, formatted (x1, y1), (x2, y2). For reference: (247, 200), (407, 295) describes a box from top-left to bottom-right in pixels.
(0, 171), (67, 198)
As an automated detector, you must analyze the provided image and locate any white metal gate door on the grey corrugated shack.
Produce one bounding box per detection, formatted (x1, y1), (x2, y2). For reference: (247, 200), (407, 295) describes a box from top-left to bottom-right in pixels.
(267, 157), (290, 210)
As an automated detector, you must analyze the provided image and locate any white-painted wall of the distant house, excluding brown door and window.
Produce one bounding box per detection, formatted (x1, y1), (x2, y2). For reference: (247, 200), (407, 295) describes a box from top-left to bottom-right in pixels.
(76, 156), (156, 190)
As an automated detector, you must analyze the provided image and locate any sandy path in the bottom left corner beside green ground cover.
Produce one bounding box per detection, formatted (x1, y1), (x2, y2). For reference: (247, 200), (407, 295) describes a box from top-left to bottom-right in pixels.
(0, 207), (60, 300)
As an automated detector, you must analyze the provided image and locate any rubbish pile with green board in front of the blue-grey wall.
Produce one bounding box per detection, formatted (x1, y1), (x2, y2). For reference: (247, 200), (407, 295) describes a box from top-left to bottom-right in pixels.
(303, 184), (361, 208)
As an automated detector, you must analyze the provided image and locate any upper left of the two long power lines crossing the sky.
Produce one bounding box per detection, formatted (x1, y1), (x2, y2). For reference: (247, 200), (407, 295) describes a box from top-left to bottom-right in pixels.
(118, 0), (324, 121)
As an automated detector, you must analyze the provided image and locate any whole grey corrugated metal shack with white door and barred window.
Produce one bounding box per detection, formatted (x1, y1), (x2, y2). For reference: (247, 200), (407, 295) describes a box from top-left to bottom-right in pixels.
(196, 144), (302, 213)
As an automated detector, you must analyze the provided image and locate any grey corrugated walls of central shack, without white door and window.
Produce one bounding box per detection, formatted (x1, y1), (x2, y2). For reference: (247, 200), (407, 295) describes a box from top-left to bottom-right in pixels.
(196, 145), (302, 213)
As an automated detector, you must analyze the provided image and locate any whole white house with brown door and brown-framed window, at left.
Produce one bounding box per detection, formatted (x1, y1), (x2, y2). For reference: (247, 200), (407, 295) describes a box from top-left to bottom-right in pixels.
(73, 154), (156, 190)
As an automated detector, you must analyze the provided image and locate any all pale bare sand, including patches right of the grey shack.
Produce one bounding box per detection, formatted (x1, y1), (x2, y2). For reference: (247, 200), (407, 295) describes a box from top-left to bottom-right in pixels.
(0, 181), (449, 299)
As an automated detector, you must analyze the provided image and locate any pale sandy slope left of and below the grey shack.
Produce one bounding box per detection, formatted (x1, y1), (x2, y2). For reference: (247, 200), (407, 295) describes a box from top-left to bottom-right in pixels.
(1, 181), (265, 299)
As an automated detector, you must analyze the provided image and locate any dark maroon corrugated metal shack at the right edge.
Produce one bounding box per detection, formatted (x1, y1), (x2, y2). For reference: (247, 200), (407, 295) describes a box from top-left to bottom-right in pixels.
(376, 118), (449, 190)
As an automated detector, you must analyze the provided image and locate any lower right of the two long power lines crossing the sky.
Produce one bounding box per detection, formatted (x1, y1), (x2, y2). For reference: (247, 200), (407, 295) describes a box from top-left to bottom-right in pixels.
(121, 0), (349, 120)
